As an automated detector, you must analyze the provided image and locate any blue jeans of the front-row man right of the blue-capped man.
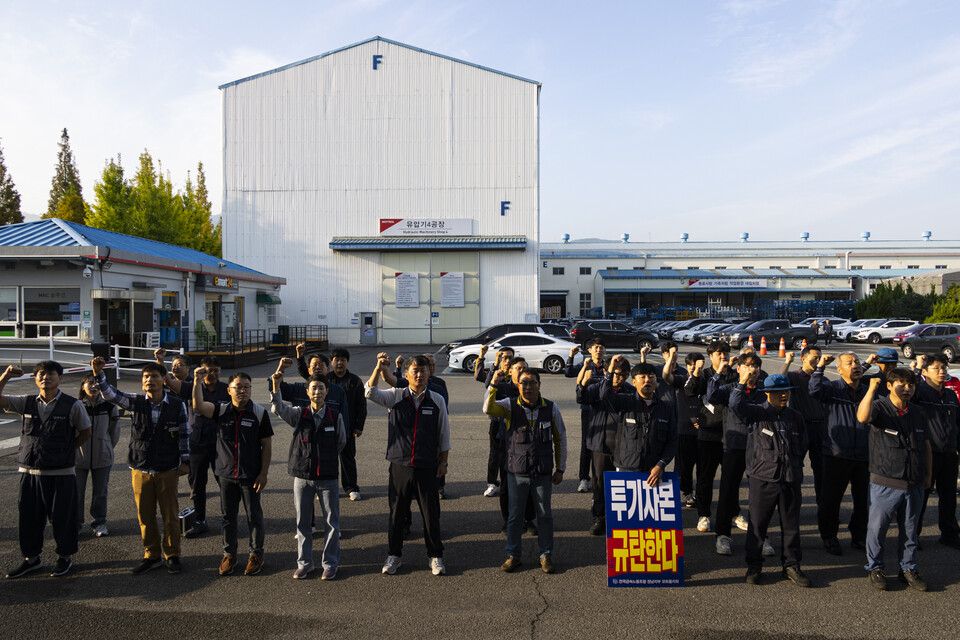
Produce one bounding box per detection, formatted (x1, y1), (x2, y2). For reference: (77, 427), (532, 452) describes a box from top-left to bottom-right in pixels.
(864, 482), (924, 571)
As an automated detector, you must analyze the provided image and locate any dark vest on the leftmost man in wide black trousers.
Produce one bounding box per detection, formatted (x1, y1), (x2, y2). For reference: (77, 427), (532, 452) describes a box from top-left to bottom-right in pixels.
(17, 392), (77, 469)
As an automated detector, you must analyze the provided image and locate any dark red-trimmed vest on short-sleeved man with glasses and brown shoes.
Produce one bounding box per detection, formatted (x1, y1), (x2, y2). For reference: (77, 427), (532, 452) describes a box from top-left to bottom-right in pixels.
(213, 401), (264, 480)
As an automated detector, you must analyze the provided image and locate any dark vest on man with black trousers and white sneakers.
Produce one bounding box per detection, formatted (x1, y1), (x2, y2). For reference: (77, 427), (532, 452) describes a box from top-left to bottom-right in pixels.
(387, 391), (440, 469)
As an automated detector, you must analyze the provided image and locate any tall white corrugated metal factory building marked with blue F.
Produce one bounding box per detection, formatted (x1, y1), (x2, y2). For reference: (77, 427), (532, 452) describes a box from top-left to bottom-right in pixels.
(220, 37), (540, 343)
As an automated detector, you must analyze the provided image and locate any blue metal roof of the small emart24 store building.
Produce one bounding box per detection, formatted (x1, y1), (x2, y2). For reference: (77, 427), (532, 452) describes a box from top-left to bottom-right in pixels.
(0, 218), (267, 275)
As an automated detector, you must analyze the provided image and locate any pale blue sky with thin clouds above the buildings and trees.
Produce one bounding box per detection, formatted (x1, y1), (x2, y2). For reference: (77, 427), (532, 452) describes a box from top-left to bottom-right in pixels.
(0, 0), (960, 241)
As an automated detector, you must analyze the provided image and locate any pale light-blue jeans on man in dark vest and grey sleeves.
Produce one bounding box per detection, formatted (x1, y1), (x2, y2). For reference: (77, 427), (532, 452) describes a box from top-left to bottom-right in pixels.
(293, 478), (340, 569)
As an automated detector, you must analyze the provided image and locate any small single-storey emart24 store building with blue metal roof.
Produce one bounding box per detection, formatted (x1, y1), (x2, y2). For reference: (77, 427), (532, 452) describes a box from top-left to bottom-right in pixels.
(0, 218), (286, 355)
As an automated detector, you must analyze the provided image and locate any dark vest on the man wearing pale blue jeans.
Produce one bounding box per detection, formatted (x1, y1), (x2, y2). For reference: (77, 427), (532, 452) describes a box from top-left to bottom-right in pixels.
(287, 405), (339, 480)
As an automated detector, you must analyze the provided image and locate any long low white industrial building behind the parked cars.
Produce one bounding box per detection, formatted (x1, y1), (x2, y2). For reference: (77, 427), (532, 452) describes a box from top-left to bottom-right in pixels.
(540, 232), (960, 317)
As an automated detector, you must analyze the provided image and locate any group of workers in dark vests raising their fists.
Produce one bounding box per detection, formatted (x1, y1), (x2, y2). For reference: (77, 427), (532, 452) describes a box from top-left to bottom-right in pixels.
(0, 339), (960, 590)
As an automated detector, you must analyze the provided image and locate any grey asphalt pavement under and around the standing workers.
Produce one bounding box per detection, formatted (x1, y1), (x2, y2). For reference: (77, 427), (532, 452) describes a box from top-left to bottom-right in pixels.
(0, 346), (960, 639)
